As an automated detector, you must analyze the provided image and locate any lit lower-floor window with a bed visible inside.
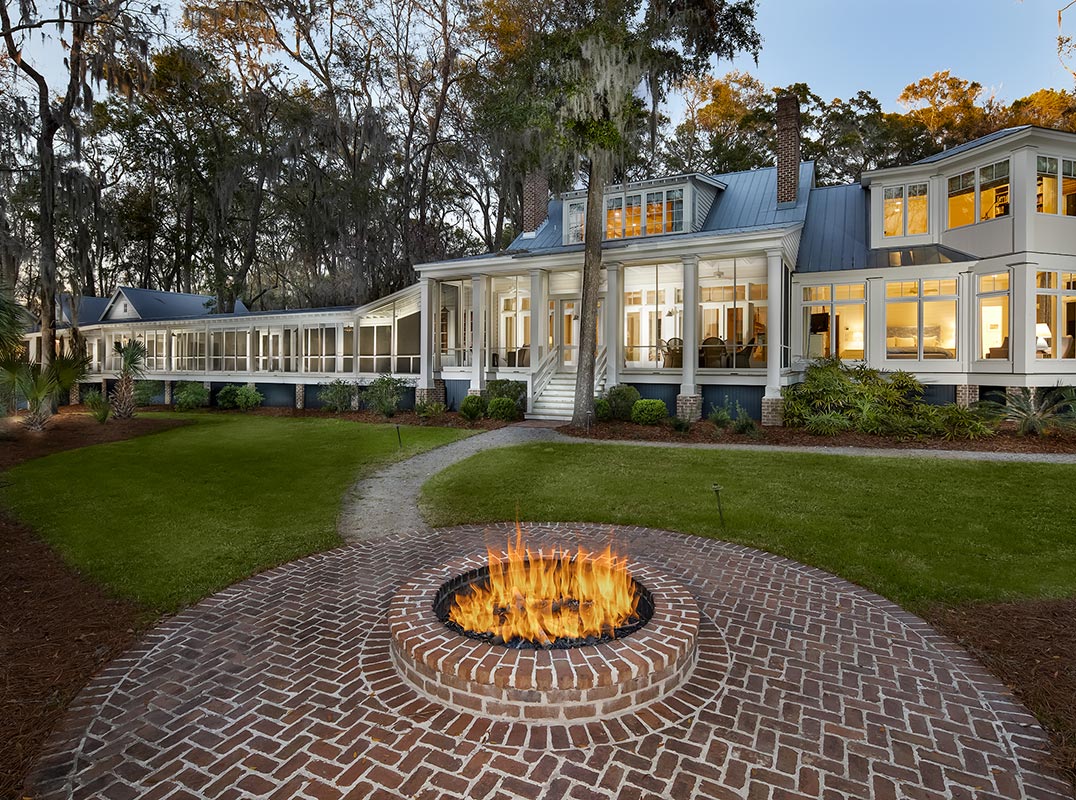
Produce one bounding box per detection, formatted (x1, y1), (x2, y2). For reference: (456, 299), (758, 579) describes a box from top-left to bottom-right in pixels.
(886, 278), (957, 360)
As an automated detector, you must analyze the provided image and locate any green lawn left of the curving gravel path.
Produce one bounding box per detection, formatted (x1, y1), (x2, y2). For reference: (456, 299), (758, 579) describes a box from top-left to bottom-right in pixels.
(0, 415), (463, 613)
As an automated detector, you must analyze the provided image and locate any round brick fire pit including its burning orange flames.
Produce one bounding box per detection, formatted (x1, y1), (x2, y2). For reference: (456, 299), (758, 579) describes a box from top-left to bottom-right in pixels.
(388, 529), (699, 722)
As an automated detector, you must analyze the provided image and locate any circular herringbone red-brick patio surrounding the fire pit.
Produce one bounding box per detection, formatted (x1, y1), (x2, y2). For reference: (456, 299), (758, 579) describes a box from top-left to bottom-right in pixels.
(34, 524), (1072, 800)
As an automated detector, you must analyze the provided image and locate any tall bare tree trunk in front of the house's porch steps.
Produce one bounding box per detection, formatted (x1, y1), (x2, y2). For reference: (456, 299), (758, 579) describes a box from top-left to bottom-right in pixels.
(571, 148), (612, 427)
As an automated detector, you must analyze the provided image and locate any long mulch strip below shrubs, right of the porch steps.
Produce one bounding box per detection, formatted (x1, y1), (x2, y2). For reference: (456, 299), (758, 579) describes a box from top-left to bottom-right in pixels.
(558, 420), (1076, 454)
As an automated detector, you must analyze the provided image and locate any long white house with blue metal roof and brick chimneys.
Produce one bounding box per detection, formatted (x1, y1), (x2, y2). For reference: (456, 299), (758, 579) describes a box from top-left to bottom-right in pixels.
(23, 97), (1076, 423)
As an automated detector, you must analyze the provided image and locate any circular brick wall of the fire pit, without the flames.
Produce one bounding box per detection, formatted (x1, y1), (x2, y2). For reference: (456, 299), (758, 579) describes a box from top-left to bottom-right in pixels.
(388, 557), (698, 722)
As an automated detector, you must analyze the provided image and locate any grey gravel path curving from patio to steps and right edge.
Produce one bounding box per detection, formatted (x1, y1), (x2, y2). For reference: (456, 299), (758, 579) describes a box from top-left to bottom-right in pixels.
(337, 423), (1076, 544)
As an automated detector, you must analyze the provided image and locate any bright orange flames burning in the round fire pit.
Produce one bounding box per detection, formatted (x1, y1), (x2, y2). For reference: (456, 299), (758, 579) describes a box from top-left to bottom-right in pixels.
(449, 523), (639, 646)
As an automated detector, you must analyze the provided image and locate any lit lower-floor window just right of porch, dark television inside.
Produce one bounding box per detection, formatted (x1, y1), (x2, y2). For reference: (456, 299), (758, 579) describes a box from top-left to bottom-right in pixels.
(803, 283), (866, 361)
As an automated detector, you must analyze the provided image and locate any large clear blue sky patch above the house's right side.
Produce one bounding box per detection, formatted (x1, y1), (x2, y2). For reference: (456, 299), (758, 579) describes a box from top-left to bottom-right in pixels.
(714, 0), (1076, 111)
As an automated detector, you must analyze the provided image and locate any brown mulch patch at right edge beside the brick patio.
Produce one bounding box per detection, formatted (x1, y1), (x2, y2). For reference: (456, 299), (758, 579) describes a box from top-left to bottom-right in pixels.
(924, 599), (1076, 784)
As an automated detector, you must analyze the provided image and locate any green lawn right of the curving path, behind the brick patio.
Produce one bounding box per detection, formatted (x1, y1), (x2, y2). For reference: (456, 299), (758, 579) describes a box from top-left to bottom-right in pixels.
(422, 445), (1076, 608)
